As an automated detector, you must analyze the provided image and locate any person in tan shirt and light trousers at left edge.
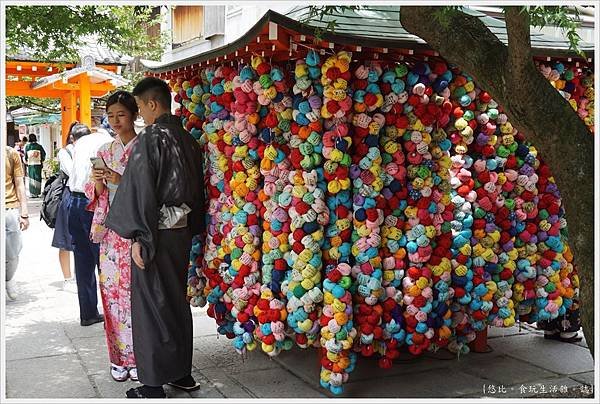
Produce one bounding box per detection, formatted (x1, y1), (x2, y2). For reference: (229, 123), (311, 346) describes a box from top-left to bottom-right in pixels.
(4, 146), (29, 300)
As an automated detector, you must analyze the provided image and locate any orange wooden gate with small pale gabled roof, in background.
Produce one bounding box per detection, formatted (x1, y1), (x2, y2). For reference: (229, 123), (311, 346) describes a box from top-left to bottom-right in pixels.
(6, 56), (129, 145)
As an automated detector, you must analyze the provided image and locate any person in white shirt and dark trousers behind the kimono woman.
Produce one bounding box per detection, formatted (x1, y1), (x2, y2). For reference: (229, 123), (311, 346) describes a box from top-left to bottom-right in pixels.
(67, 123), (113, 327)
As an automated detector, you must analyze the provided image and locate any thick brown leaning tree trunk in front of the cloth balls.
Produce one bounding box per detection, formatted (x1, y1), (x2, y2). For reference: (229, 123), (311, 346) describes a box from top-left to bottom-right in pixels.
(400, 6), (594, 356)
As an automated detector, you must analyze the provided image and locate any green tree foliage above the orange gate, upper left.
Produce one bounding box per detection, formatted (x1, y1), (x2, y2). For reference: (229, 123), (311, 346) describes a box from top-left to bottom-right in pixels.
(6, 5), (164, 61)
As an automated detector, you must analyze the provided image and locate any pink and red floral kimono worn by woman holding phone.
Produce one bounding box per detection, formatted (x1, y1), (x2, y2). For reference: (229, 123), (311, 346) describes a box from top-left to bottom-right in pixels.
(85, 135), (137, 368)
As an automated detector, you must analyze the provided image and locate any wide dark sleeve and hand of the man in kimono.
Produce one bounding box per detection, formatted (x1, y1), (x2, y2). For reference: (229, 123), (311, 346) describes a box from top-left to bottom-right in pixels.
(105, 133), (160, 266)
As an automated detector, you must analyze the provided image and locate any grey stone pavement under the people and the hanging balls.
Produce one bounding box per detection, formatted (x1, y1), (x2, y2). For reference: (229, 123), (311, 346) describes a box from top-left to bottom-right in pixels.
(3, 201), (594, 399)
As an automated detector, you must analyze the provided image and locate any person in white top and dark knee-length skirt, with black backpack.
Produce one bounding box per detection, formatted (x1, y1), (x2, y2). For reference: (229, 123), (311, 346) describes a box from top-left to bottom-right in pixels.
(52, 131), (77, 292)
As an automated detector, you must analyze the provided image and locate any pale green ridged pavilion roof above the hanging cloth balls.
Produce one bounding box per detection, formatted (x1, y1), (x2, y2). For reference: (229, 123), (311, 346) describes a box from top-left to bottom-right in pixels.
(142, 6), (594, 73)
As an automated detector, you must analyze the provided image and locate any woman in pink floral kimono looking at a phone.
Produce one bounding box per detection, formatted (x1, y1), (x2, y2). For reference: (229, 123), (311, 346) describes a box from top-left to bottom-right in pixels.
(85, 91), (138, 381)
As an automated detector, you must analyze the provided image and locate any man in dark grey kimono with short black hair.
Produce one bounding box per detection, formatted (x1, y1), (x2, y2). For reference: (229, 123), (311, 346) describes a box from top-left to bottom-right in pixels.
(106, 77), (205, 398)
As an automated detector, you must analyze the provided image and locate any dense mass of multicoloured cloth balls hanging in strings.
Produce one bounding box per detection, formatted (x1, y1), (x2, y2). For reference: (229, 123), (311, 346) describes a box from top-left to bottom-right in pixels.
(178, 51), (594, 394)
